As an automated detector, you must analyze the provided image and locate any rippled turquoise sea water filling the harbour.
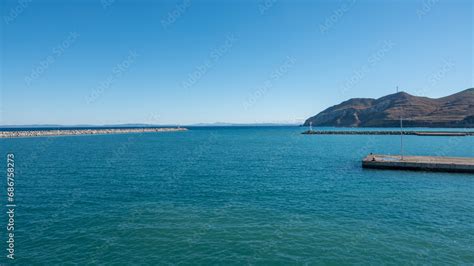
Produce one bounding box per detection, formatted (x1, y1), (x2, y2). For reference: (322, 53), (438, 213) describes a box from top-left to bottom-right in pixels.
(0, 127), (474, 265)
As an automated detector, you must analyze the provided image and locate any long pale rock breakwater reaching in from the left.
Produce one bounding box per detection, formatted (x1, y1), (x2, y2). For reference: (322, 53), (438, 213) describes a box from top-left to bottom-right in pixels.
(0, 128), (187, 138)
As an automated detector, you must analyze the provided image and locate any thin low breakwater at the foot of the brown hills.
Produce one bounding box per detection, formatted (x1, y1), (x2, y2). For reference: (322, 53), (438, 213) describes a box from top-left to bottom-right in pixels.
(302, 130), (474, 137)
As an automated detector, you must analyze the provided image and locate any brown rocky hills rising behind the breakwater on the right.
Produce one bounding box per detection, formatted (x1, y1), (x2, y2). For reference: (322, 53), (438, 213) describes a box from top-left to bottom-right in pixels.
(304, 88), (474, 128)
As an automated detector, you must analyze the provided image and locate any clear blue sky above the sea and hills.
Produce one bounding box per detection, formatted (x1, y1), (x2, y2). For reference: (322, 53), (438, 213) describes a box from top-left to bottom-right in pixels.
(0, 0), (474, 125)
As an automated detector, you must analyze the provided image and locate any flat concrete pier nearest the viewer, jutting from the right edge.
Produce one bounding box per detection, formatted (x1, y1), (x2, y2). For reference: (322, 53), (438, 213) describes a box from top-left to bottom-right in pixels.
(362, 154), (474, 173)
